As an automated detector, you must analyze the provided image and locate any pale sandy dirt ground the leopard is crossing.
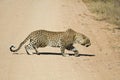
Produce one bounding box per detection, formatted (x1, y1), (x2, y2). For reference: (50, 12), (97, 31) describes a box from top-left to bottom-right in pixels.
(0, 0), (120, 80)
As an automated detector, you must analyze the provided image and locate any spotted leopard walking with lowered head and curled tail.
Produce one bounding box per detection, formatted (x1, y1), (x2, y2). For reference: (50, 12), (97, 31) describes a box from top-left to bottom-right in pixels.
(10, 28), (91, 57)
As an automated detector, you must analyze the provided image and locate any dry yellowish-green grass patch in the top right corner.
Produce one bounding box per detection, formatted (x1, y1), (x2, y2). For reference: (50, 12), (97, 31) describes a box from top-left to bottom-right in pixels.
(83, 0), (120, 29)
